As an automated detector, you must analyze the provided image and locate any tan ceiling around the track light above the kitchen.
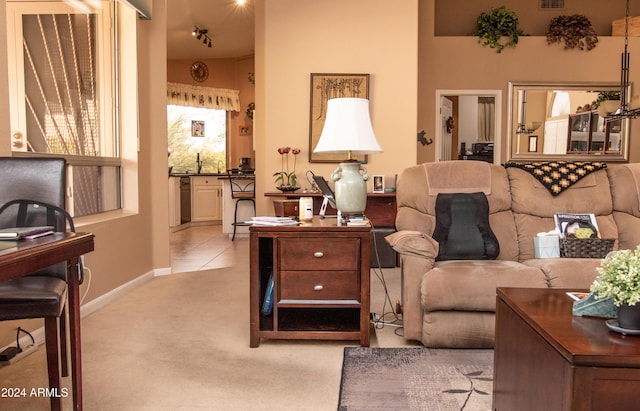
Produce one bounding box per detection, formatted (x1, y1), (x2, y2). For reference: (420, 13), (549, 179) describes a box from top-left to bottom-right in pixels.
(167, 0), (254, 60)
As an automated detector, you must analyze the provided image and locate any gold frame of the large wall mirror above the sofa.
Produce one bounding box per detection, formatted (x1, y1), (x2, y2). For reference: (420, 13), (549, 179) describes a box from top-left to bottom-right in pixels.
(506, 81), (631, 162)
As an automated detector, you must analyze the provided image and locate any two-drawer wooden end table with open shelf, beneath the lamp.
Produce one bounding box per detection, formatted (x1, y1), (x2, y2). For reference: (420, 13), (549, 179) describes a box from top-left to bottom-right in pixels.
(249, 217), (371, 347)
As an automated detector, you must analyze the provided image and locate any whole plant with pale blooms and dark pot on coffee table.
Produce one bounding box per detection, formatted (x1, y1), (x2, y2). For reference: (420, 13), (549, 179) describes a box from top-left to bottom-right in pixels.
(591, 245), (640, 330)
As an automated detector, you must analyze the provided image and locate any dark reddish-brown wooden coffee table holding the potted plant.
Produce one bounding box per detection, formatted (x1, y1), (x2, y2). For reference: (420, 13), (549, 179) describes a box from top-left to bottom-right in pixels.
(493, 288), (640, 411)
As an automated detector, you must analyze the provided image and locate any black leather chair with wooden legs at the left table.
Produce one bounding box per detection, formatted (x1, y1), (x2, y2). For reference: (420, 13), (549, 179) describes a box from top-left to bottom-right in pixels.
(0, 158), (81, 410)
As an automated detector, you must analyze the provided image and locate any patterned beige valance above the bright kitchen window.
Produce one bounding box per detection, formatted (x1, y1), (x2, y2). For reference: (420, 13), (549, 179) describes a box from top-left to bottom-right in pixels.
(167, 83), (240, 111)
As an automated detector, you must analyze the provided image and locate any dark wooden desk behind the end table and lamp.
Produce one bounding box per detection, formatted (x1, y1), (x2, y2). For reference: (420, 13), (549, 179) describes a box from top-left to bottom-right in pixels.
(264, 191), (396, 227)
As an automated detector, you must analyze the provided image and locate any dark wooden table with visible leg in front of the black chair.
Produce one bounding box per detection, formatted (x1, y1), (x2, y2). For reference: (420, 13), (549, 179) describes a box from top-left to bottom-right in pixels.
(0, 233), (94, 410)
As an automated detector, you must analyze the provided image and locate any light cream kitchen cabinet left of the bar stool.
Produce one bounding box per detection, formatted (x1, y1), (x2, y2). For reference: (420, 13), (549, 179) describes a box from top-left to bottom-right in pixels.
(191, 176), (222, 223)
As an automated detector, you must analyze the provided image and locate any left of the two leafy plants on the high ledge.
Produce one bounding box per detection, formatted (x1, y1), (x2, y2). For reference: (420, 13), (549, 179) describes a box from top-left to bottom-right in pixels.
(473, 6), (524, 53)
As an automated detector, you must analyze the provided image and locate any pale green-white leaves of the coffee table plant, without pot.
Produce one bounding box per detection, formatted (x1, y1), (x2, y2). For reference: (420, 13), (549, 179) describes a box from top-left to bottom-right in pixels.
(591, 246), (640, 306)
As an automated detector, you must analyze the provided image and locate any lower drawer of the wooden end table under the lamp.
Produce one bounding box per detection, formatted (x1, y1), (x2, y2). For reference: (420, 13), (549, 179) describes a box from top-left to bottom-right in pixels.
(279, 271), (360, 301)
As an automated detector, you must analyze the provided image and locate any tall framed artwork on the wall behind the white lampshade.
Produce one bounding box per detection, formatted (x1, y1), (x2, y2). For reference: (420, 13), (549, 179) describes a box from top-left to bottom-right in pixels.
(309, 73), (369, 164)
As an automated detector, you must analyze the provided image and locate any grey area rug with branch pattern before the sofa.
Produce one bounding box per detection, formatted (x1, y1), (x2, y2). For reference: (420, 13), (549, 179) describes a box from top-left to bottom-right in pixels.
(338, 347), (493, 411)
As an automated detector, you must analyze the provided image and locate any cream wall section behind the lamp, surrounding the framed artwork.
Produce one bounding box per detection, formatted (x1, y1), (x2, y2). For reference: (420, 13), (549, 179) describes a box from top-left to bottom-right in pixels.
(256, 0), (418, 214)
